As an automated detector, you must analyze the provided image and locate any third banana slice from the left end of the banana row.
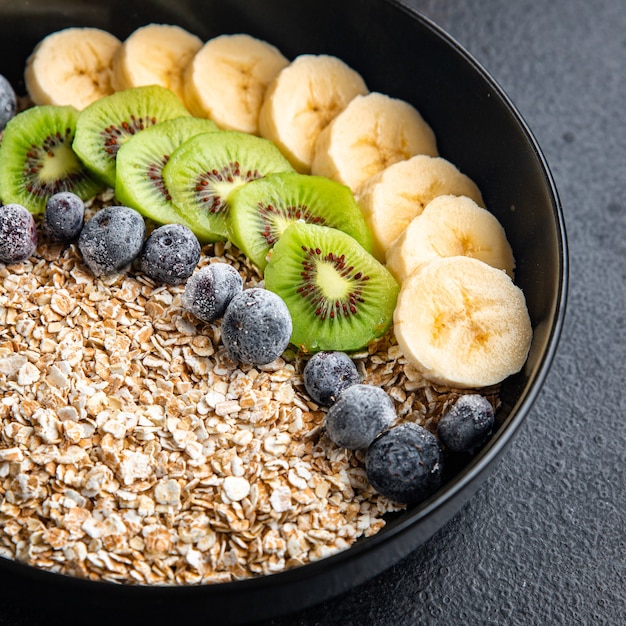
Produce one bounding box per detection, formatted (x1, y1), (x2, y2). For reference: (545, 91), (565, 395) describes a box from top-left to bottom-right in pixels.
(180, 34), (289, 135)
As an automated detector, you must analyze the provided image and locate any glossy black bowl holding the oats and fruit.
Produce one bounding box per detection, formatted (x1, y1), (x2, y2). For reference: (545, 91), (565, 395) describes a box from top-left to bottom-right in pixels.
(0, 0), (567, 624)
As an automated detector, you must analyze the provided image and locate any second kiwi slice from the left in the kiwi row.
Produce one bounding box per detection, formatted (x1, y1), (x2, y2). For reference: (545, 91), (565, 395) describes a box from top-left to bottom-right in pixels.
(73, 85), (191, 187)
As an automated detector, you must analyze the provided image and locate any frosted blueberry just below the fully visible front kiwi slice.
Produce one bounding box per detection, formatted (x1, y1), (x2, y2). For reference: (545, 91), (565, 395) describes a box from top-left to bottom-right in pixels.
(303, 352), (360, 406)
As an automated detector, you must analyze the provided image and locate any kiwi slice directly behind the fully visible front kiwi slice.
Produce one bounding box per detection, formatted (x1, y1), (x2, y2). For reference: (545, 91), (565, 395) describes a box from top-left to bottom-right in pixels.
(230, 172), (372, 270)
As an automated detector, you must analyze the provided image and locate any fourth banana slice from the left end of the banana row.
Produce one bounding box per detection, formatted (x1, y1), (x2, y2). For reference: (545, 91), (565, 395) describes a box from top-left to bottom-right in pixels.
(259, 54), (368, 174)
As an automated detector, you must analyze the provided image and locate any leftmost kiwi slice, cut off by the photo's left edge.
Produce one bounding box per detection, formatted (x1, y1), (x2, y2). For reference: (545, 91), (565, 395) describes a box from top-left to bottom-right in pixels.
(0, 105), (104, 213)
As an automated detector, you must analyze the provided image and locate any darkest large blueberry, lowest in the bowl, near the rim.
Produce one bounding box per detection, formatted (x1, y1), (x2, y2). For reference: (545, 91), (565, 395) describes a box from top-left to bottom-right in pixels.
(365, 422), (443, 504)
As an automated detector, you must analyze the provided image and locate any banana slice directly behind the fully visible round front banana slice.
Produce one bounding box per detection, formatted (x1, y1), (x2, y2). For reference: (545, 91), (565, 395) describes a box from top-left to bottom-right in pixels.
(387, 195), (515, 282)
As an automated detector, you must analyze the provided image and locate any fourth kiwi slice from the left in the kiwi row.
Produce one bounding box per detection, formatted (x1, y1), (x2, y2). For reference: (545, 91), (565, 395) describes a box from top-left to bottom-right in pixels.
(163, 131), (293, 241)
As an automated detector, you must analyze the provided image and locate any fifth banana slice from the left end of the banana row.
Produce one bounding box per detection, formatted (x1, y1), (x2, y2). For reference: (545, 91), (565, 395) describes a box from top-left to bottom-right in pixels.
(311, 92), (438, 191)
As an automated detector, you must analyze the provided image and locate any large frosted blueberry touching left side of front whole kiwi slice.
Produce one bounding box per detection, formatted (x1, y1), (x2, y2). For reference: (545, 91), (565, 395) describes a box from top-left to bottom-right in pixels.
(222, 287), (293, 365)
